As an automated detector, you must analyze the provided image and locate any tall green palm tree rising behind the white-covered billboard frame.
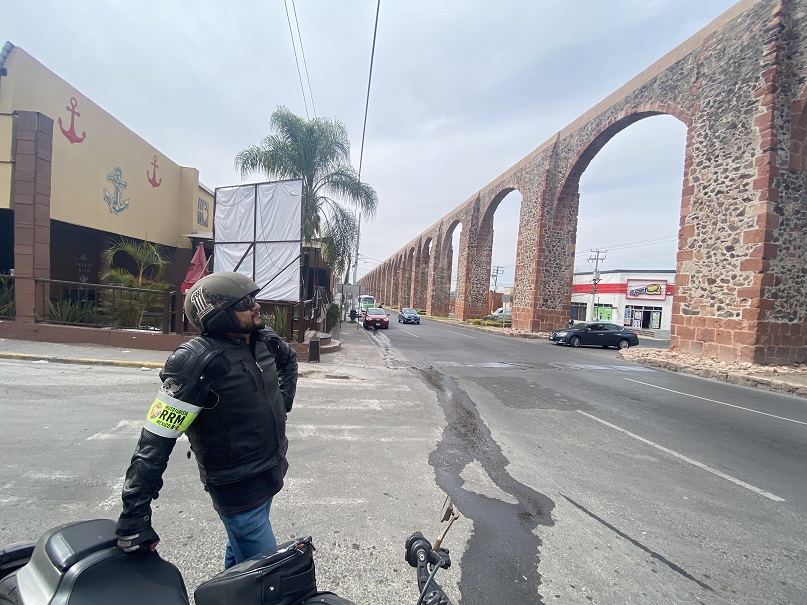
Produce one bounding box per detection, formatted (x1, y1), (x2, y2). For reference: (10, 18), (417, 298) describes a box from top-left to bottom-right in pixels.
(235, 106), (378, 274)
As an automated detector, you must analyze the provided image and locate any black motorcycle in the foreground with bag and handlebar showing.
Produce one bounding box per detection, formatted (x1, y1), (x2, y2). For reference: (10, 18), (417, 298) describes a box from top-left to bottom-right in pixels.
(0, 497), (459, 605)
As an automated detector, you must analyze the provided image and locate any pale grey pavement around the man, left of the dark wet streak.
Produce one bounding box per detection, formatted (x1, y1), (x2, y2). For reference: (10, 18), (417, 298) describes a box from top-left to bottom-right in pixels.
(0, 352), (471, 605)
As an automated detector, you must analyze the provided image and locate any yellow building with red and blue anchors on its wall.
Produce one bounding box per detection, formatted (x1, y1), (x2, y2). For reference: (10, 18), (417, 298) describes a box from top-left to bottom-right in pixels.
(0, 42), (214, 332)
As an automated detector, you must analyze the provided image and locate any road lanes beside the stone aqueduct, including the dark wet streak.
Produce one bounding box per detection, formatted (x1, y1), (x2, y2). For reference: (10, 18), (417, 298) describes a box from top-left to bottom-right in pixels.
(364, 313), (807, 604)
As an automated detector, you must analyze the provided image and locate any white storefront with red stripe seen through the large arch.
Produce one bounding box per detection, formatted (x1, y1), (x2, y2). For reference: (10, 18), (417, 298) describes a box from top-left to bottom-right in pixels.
(571, 269), (675, 338)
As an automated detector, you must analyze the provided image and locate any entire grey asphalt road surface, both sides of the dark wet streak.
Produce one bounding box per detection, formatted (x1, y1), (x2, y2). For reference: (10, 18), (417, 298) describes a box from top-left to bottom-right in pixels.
(0, 314), (807, 605)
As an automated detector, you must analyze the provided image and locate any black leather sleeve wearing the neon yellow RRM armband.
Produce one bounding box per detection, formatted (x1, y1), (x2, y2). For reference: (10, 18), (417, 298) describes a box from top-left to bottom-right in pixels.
(117, 341), (227, 536)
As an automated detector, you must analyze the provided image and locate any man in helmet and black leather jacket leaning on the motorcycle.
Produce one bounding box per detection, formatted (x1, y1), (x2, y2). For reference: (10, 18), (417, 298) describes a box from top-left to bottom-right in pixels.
(117, 272), (297, 568)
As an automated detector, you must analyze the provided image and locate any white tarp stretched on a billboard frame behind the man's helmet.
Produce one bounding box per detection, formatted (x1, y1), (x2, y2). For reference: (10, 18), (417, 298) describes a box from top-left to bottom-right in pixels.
(213, 180), (303, 302)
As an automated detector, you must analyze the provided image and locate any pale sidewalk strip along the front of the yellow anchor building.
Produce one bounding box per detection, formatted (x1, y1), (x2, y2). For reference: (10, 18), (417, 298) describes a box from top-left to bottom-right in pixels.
(0, 322), (384, 378)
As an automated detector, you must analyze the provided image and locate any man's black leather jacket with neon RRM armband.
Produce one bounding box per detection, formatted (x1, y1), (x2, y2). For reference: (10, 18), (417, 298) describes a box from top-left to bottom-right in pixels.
(118, 329), (297, 535)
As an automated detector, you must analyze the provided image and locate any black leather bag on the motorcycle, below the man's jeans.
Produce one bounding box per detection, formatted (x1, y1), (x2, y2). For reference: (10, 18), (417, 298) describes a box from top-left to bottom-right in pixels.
(193, 536), (317, 605)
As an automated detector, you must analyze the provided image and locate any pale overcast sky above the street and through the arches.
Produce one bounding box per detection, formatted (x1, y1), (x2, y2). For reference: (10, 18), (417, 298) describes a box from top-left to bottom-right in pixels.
(0, 0), (734, 290)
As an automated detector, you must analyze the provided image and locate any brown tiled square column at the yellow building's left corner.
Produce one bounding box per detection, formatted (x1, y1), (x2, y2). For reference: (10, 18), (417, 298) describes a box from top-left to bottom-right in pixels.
(13, 111), (53, 323)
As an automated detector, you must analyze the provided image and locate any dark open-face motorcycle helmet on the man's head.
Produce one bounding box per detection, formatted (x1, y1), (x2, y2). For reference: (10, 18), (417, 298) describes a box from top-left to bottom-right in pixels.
(185, 271), (260, 334)
